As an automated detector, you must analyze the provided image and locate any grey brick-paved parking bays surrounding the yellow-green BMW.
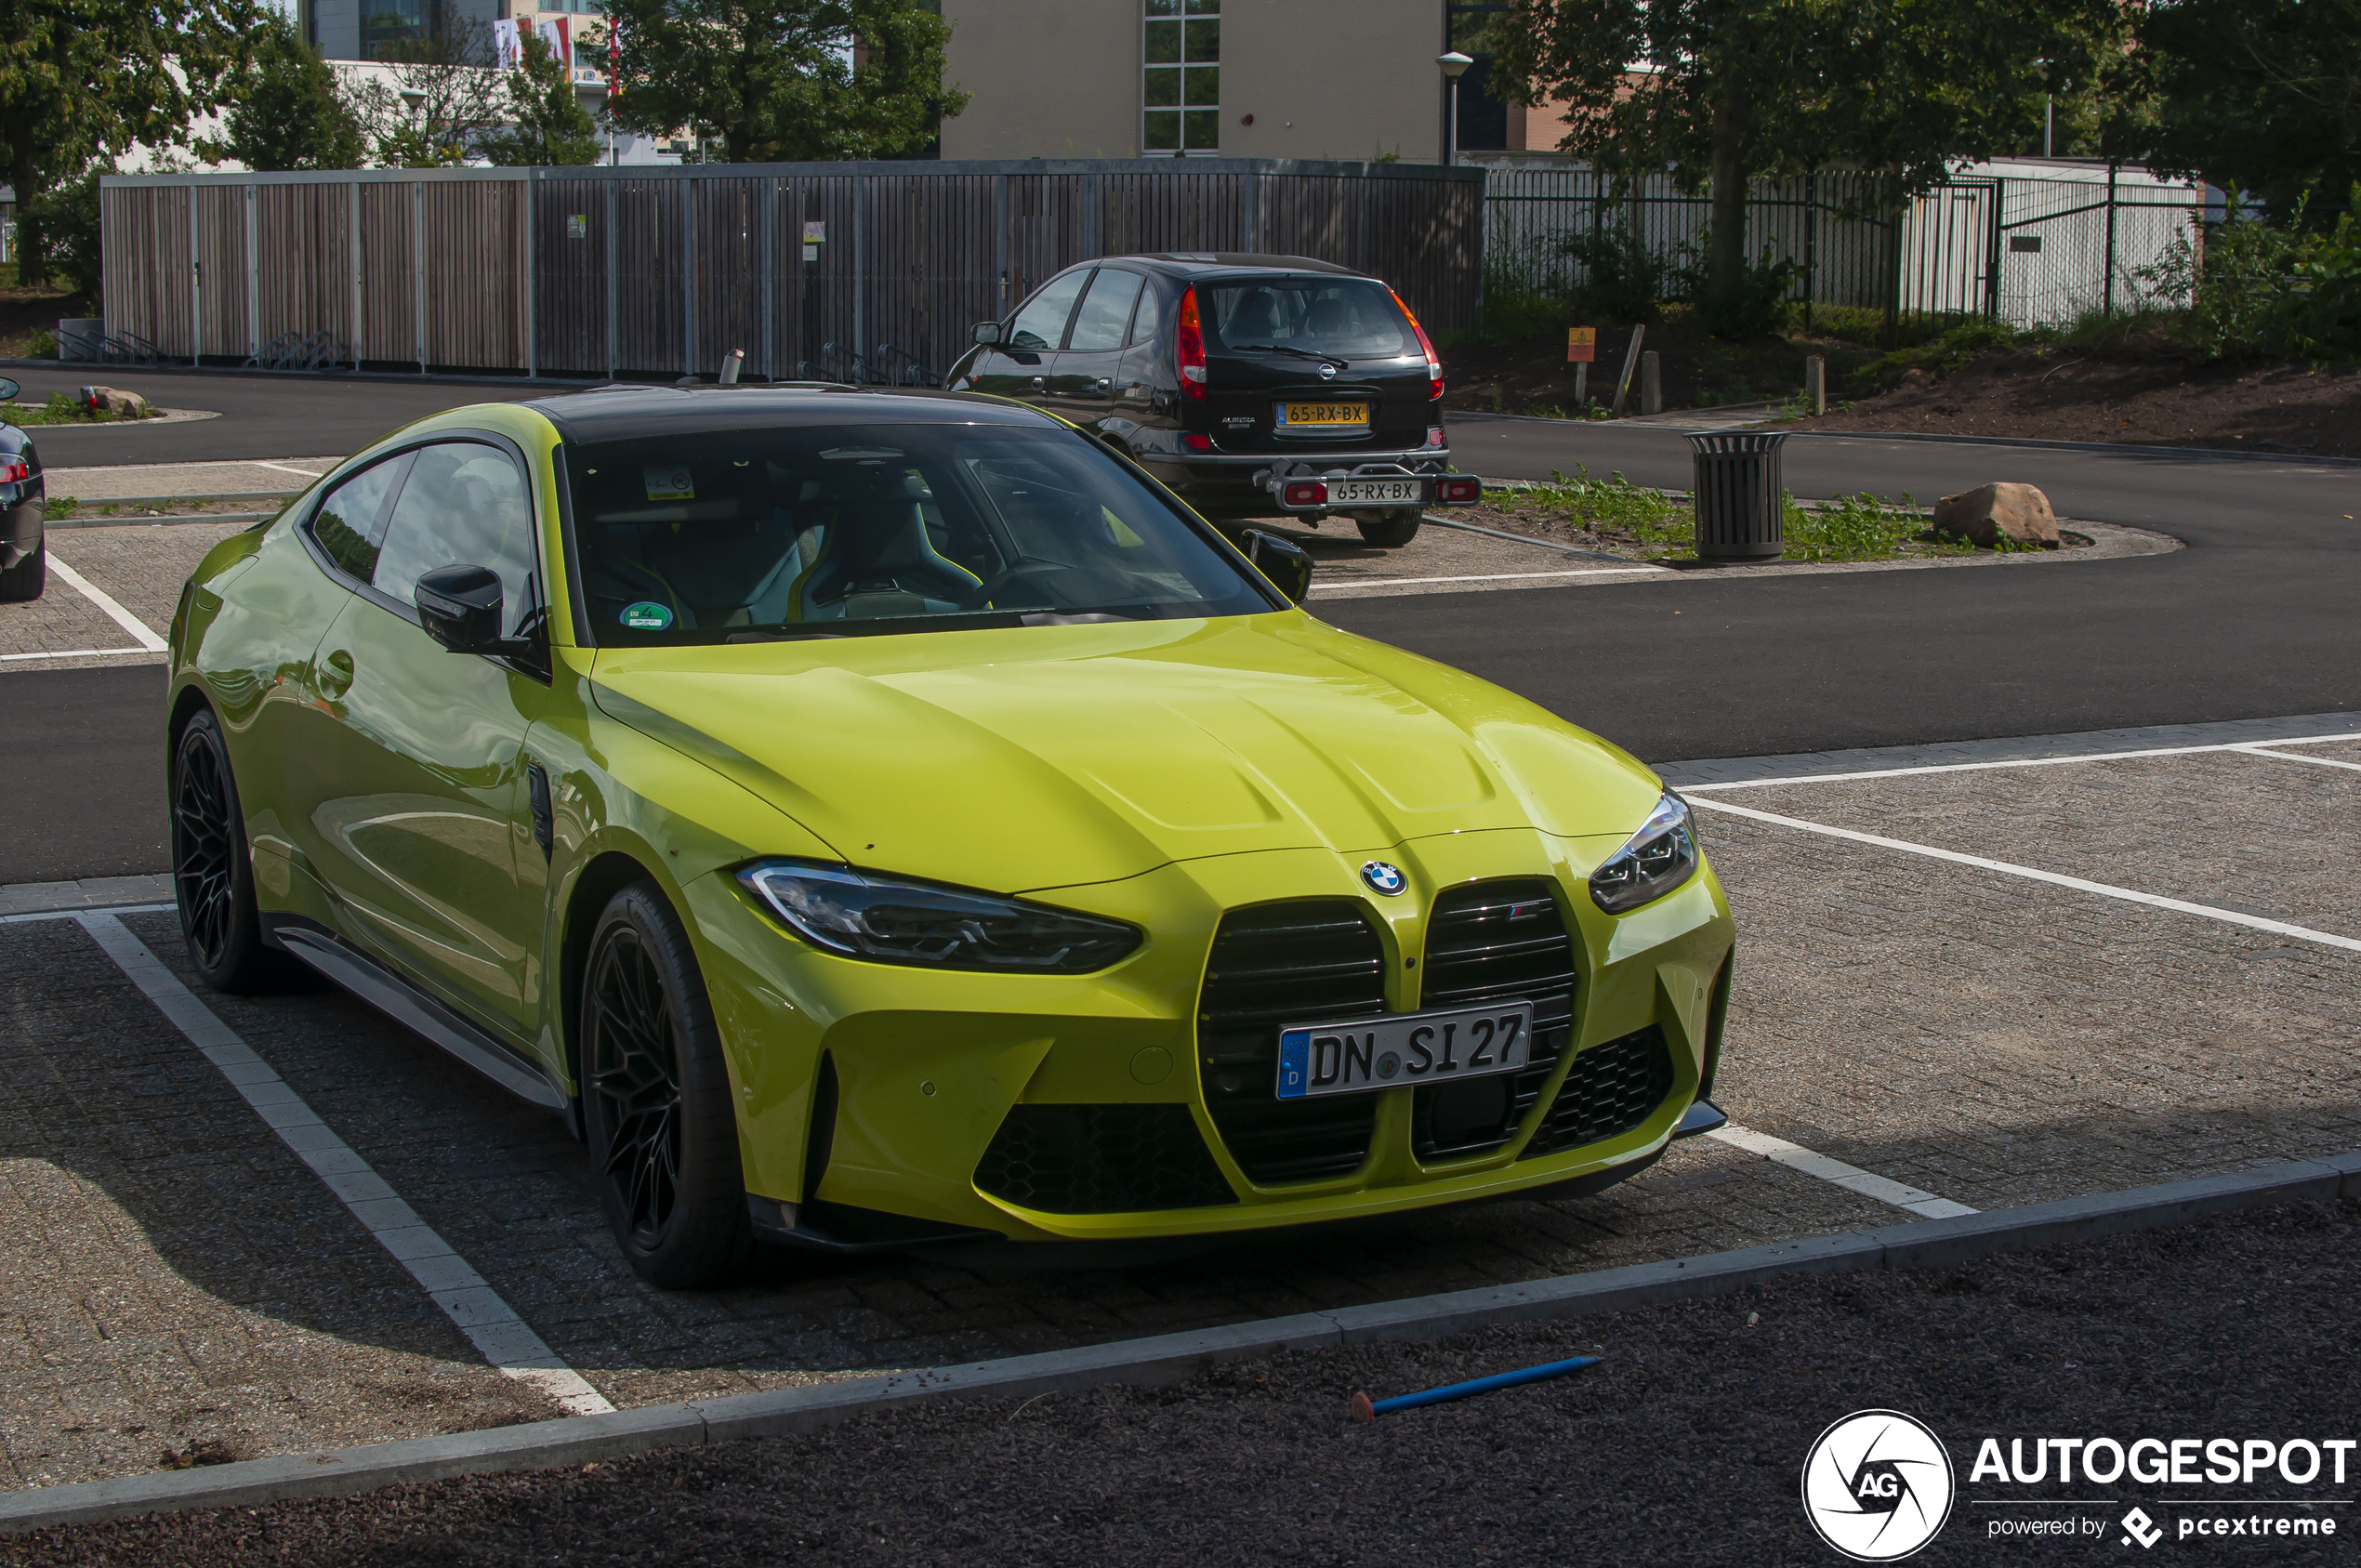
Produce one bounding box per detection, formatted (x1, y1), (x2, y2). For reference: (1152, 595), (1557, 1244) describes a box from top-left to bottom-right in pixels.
(0, 720), (2361, 1488)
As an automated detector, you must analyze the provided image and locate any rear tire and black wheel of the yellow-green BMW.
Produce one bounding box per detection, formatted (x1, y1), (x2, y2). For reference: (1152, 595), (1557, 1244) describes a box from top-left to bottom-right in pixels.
(172, 711), (302, 996)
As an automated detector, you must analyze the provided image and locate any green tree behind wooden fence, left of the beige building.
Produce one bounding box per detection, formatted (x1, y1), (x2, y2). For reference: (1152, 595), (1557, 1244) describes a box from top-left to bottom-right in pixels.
(607, 0), (968, 163)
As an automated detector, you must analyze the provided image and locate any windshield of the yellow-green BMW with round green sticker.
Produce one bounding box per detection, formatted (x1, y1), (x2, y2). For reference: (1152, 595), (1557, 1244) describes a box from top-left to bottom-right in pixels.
(567, 425), (1277, 647)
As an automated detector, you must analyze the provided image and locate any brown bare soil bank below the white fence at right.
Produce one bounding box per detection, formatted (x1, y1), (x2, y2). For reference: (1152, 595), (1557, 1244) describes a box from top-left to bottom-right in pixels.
(1775, 347), (2361, 458)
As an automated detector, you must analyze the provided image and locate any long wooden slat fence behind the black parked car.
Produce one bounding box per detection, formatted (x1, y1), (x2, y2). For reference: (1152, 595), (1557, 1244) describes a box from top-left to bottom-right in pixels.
(101, 158), (1485, 383)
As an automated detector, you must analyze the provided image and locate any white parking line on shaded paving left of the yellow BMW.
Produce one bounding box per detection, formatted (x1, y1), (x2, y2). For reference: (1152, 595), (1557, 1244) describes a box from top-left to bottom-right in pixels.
(73, 912), (613, 1415)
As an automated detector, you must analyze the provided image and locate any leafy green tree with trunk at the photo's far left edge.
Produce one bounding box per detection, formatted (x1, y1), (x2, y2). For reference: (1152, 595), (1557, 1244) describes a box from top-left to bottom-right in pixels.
(0, 0), (255, 283)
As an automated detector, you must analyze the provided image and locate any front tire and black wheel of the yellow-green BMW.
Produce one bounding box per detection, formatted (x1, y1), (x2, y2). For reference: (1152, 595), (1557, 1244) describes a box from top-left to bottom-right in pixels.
(581, 881), (753, 1289)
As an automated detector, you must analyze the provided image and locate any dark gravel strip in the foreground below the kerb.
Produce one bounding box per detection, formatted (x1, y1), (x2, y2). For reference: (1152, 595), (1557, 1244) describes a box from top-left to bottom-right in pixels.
(0, 1205), (2361, 1568)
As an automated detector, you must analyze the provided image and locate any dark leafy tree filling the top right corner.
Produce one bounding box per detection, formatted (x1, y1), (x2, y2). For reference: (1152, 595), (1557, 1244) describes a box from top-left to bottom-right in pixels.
(2128, 0), (2361, 213)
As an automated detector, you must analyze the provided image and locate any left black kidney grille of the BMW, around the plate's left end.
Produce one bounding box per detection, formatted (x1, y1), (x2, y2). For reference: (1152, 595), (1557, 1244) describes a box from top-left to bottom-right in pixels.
(1197, 897), (1386, 1185)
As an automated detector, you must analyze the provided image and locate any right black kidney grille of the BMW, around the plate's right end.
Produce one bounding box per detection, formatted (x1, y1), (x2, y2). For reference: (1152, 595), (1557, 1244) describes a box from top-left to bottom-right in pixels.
(1409, 878), (1577, 1159)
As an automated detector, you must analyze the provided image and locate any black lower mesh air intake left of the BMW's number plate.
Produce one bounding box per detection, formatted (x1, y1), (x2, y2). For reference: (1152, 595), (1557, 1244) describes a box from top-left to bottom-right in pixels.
(975, 1105), (1237, 1214)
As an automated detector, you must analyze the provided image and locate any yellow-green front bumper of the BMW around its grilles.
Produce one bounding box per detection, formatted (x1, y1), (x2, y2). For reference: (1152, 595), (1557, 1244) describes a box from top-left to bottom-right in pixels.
(687, 829), (1733, 1240)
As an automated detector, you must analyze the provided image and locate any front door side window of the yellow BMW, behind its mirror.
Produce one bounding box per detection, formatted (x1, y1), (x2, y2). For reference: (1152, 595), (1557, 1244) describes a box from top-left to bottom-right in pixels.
(368, 441), (541, 638)
